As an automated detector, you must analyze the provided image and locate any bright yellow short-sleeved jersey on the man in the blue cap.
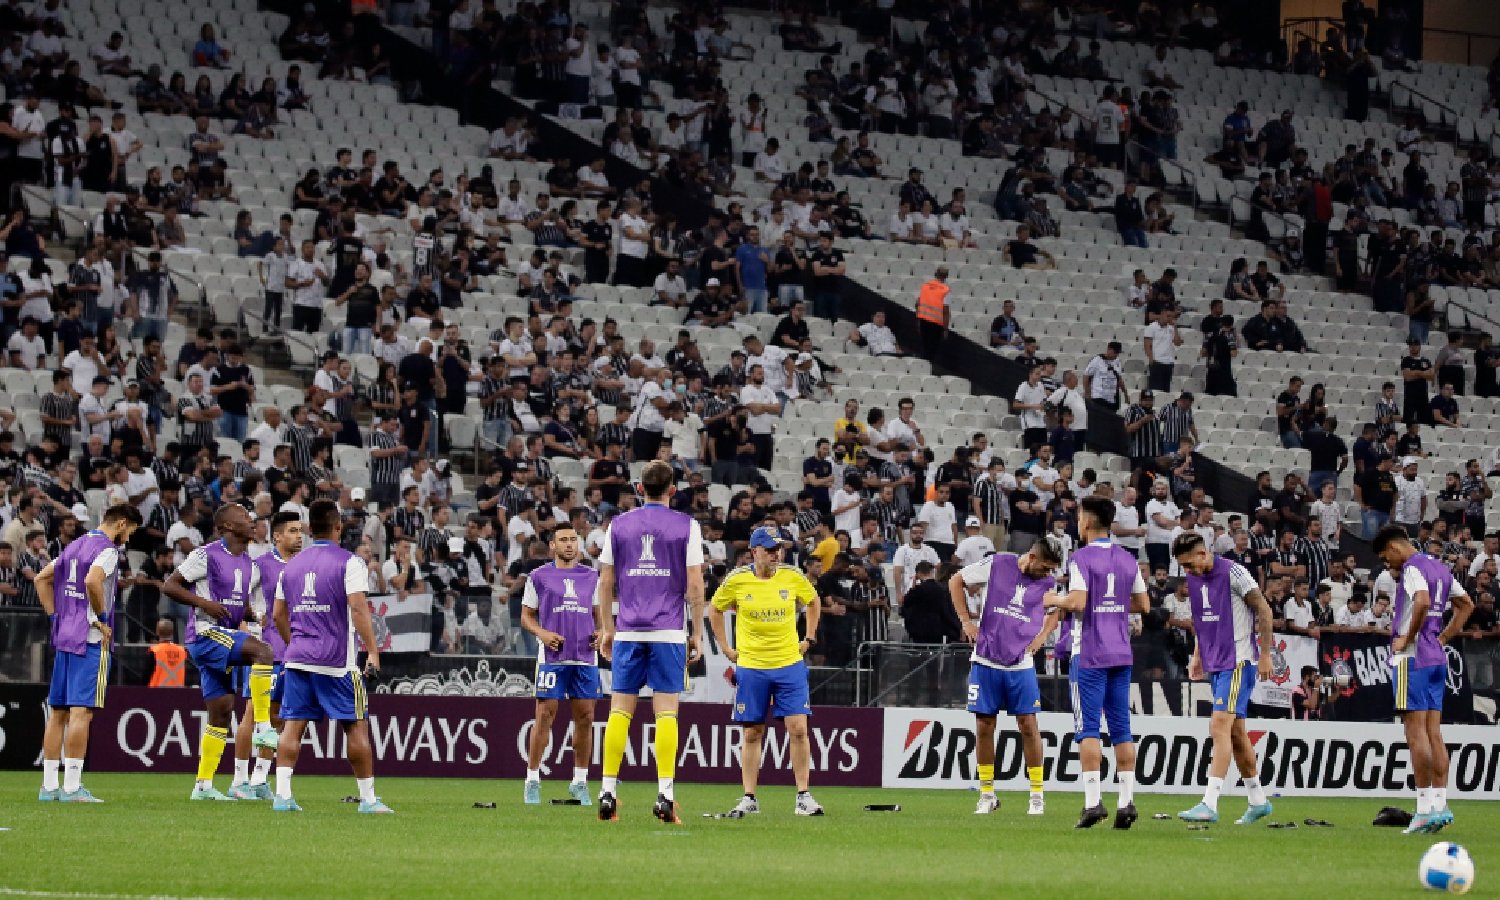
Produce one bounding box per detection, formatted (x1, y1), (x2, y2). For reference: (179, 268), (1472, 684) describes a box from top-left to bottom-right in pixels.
(714, 566), (818, 669)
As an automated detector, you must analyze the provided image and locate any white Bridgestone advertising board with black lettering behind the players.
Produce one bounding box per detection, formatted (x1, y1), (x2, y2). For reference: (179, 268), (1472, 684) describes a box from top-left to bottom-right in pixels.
(881, 710), (1500, 800)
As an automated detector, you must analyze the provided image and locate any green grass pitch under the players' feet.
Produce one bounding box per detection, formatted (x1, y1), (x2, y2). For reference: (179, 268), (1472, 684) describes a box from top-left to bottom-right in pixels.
(0, 773), (1500, 900)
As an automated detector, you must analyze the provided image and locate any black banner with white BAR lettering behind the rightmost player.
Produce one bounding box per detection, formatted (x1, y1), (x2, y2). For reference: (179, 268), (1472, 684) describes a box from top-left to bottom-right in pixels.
(1319, 632), (1475, 723)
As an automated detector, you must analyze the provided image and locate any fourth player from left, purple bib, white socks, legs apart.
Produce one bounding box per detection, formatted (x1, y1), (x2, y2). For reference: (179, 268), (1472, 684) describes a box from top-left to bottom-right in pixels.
(272, 500), (393, 813)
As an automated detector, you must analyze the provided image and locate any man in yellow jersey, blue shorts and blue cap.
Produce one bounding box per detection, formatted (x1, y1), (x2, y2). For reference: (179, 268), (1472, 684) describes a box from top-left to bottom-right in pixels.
(708, 528), (824, 819)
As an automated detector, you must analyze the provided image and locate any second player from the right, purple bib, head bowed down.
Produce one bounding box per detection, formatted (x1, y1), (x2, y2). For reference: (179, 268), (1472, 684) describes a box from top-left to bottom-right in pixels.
(1172, 531), (1274, 825)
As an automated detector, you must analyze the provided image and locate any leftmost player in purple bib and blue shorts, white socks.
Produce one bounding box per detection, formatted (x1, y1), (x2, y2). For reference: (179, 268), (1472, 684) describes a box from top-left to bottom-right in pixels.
(36, 504), (141, 803)
